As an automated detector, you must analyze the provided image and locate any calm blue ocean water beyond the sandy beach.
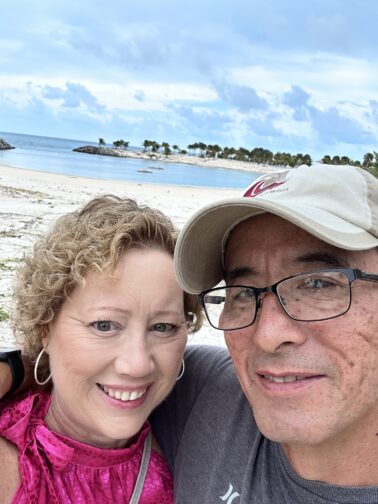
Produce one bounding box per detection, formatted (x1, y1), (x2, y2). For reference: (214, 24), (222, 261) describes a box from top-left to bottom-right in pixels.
(0, 131), (259, 189)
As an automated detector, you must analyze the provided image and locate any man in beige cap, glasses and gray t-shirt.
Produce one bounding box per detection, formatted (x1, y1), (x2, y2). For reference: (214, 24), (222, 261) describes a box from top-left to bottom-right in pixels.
(151, 166), (378, 504)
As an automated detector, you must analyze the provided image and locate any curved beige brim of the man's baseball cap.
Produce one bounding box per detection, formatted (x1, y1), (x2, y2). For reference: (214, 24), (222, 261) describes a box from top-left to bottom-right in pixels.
(175, 197), (378, 294)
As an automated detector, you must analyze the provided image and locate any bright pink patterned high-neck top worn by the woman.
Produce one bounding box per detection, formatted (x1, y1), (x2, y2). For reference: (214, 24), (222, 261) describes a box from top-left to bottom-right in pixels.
(0, 392), (173, 504)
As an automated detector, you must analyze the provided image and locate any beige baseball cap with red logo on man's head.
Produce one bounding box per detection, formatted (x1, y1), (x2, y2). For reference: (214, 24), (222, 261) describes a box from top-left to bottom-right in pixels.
(175, 164), (378, 294)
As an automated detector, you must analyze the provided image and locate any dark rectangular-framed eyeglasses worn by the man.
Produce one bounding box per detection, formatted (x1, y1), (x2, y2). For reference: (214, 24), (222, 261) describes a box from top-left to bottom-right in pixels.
(199, 268), (378, 331)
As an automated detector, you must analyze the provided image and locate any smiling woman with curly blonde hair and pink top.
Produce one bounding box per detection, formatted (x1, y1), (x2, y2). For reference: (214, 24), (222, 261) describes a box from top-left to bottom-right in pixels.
(0, 196), (200, 504)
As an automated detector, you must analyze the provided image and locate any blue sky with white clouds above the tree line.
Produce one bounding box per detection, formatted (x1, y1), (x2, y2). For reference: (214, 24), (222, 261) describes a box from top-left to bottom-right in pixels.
(0, 0), (378, 159)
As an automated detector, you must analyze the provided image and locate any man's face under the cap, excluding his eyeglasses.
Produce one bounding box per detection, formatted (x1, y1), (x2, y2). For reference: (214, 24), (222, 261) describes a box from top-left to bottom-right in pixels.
(225, 214), (378, 446)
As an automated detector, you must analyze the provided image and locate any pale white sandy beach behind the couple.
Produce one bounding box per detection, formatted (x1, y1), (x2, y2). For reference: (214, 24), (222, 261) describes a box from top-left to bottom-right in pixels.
(0, 165), (236, 344)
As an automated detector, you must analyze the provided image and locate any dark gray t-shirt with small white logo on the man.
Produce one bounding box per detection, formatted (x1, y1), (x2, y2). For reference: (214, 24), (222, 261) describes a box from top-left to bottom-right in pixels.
(151, 346), (378, 504)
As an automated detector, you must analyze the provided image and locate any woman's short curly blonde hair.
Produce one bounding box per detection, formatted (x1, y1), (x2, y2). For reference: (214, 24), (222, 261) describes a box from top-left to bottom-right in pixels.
(12, 195), (202, 374)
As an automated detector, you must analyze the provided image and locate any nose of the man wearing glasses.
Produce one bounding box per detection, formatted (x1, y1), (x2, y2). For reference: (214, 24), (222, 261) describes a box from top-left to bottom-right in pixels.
(247, 292), (306, 353)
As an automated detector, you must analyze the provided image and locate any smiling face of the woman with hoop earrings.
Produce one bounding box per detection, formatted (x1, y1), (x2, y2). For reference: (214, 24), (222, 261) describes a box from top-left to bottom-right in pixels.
(43, 249), (187, 447)
